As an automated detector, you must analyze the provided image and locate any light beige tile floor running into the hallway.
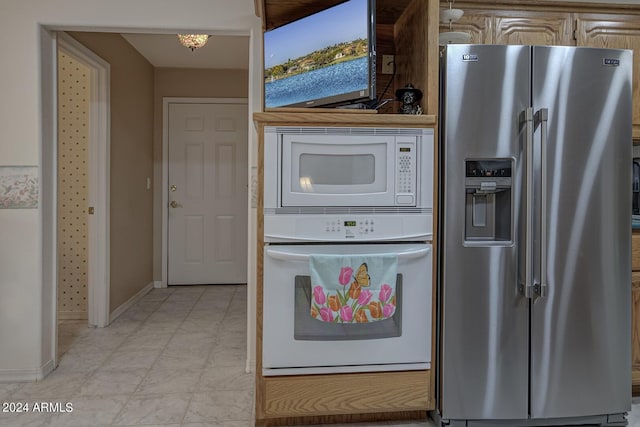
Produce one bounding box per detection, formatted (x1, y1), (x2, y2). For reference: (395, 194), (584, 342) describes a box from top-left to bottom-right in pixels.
(0, 286), (640, 427)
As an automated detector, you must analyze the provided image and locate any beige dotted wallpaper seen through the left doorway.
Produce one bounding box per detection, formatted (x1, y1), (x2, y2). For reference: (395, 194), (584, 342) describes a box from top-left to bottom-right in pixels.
(58, 51), (90, 319)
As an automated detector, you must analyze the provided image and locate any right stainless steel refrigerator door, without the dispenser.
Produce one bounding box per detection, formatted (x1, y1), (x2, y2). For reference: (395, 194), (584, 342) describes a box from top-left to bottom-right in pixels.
(531, 47), (632, 418)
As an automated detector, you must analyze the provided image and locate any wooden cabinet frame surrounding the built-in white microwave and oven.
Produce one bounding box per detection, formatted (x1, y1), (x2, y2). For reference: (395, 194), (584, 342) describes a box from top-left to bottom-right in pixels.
(254, 109), (437, 425)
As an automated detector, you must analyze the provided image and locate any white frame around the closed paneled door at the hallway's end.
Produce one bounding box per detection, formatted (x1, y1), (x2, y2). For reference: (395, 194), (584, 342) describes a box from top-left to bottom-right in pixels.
(160, 97), (251, 288)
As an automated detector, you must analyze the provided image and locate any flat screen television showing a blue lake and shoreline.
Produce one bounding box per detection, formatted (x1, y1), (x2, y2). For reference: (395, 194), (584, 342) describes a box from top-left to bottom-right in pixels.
(264, 0), (376, 108)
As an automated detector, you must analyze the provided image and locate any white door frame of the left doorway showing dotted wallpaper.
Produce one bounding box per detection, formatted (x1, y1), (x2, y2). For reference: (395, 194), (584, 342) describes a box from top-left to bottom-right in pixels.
(54, 32), (111, 328)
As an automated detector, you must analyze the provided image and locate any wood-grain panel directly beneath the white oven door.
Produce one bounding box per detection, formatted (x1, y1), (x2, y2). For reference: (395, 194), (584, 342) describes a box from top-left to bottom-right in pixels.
(263, 371), (431, 419)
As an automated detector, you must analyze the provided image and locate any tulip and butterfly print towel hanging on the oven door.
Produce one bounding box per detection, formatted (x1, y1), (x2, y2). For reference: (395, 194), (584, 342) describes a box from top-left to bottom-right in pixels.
(309, 255), (398, 323)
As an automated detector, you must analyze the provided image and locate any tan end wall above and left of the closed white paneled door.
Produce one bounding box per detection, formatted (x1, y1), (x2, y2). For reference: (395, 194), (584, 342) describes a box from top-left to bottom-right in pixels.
(153, 67), (249, 282)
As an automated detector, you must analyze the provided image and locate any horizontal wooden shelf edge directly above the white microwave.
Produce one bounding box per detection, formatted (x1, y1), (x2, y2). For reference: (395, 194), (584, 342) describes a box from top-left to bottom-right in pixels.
(253, 110), (436, 127)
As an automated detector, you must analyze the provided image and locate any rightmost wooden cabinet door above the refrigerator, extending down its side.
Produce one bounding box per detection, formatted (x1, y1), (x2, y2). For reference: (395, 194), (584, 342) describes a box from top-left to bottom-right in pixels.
(576, 14), (640, 138)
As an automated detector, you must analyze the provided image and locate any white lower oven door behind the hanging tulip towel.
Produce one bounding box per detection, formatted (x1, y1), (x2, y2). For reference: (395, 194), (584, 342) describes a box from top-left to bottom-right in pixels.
(262, 243), (432, 375)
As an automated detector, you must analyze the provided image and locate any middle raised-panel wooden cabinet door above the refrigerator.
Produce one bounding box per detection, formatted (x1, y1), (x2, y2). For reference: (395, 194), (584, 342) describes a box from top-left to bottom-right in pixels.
(493, 11), (575, 46)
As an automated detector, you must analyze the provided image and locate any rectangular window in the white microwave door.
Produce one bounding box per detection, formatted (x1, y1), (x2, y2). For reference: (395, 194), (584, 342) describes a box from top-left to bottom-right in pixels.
(299, 153), (376, 187)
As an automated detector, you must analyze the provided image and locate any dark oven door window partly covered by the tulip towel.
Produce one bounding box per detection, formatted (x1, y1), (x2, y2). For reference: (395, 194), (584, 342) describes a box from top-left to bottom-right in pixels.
(293, 274), (402, 341)
